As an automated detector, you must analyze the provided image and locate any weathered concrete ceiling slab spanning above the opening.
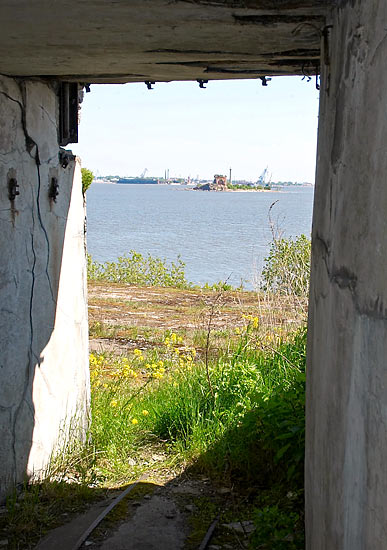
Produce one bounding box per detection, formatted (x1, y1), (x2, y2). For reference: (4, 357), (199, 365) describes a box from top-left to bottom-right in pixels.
(0, 0), (331, 83)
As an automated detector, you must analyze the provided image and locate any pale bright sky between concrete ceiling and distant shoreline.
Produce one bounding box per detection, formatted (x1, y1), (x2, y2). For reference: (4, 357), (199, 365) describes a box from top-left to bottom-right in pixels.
(71, 77), (319, 183)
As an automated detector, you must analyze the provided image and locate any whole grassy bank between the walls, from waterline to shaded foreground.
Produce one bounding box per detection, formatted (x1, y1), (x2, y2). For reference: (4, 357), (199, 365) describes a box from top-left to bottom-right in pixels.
(0, 244), (312, 550)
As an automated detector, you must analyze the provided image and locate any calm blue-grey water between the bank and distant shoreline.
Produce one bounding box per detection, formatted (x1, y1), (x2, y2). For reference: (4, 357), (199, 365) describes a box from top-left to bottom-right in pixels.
(87, 183), (313, 286)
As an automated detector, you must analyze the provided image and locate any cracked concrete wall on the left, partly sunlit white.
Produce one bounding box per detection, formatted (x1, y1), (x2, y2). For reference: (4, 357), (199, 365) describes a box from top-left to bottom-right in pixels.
(0, 73), (89, 498)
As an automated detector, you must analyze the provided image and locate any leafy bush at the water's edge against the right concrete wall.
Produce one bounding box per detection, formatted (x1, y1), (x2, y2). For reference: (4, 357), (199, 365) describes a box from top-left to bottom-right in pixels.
(261, 235), (311, 296)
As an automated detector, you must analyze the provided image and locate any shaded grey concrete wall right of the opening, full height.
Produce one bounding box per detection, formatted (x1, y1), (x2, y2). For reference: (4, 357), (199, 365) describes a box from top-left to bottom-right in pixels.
(306, 0), (387, 550)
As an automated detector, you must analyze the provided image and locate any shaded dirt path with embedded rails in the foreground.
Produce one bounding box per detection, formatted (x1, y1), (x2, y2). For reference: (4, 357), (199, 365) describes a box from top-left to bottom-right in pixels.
(36, 475), (254, 550)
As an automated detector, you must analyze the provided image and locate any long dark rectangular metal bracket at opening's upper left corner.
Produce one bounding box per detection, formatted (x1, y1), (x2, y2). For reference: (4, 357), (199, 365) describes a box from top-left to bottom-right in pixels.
(59, 82), (79, 145)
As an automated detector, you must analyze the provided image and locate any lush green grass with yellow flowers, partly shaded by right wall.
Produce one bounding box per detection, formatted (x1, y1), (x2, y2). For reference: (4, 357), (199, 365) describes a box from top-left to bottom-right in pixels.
(84, 324), (306, 549)
